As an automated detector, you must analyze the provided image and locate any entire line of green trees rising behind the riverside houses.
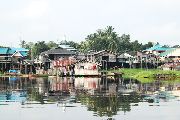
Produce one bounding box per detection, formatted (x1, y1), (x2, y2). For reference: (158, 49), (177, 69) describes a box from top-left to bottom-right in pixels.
(14, 26), (167, 57)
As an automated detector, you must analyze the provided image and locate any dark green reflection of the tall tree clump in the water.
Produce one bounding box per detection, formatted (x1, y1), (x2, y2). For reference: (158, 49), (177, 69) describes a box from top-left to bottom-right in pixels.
(77, 93), (140, 117)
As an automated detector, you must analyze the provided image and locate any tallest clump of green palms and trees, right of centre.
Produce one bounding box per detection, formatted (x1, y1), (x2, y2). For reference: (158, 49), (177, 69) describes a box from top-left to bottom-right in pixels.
(79, 26), (153, 53)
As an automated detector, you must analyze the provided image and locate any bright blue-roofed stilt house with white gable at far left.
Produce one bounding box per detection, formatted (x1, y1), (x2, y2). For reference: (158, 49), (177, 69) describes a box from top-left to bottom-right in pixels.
(0, 47), (29, 72)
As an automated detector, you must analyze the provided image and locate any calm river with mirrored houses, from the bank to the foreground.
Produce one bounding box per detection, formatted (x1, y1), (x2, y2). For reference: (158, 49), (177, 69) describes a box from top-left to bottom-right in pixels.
(0, 77), (180, 120)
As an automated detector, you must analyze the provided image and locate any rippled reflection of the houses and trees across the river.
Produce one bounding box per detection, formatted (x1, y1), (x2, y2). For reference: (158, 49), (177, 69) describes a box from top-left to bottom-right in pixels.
(0, 77), (180, 117)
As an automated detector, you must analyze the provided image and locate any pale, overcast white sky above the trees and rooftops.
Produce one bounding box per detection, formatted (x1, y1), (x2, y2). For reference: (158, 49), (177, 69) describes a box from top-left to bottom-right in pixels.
(0, 0), (180, 47)
